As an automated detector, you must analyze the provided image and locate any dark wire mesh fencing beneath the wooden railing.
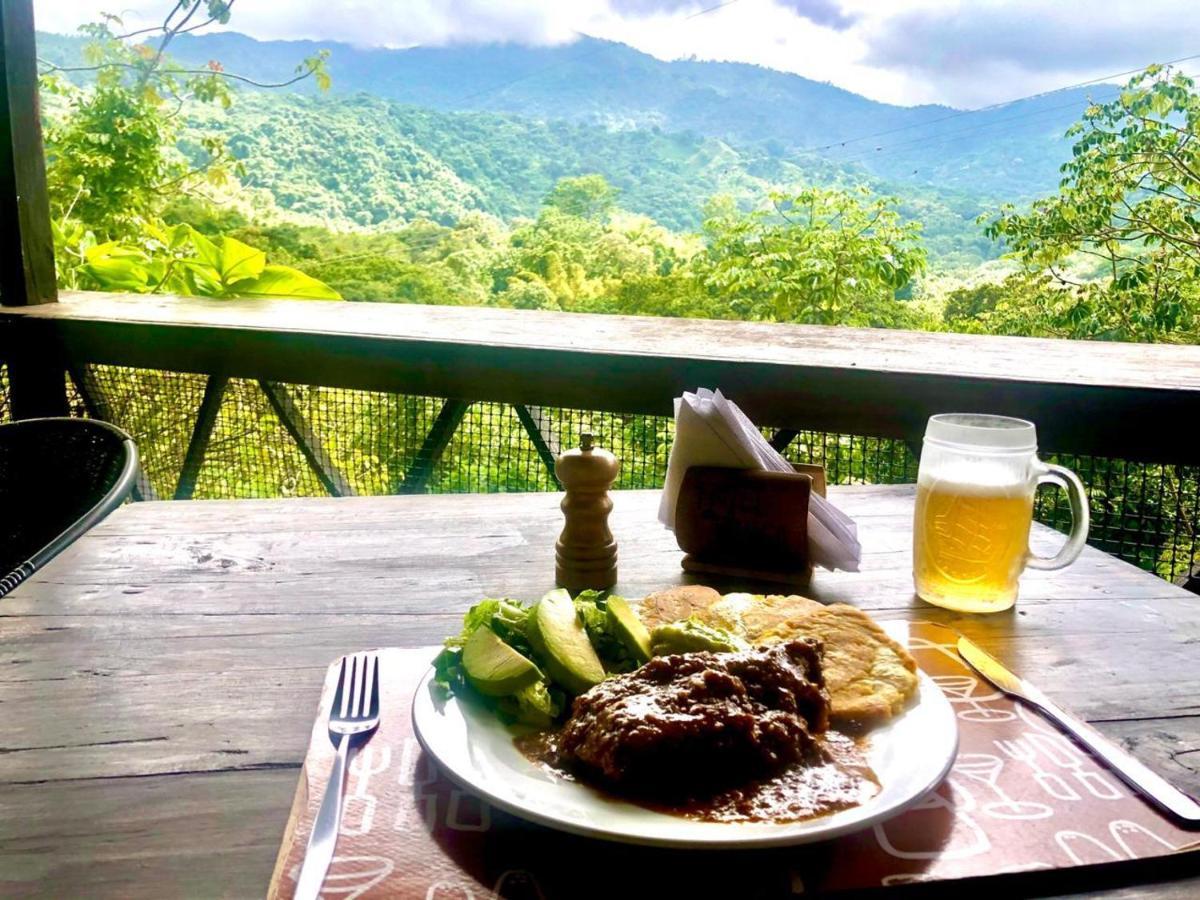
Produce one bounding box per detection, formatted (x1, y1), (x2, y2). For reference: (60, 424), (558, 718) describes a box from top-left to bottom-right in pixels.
(0, 366), (1200, 578)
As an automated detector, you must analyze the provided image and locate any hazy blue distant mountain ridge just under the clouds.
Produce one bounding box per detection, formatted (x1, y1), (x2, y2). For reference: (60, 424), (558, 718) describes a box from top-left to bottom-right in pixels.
(152, 32), (1117, 200)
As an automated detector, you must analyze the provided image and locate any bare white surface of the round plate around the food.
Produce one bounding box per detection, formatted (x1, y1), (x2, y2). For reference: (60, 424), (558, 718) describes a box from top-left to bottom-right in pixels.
(413, 652), (959, 848)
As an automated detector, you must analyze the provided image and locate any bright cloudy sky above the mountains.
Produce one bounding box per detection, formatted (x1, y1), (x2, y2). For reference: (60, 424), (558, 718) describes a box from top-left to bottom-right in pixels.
(34, 0), (1200, 107)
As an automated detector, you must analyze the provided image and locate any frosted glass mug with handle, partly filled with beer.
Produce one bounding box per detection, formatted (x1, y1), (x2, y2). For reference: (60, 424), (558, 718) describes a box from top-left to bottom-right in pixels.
(912, 413), (1088, 612)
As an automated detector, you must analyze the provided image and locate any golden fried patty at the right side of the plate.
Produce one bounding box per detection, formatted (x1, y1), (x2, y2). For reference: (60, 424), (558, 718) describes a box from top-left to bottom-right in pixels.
(760, 604), (917, 728)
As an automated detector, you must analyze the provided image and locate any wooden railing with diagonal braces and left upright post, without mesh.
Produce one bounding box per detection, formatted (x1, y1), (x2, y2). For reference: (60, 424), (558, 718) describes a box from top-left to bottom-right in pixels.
(0, 0), (1200, 585)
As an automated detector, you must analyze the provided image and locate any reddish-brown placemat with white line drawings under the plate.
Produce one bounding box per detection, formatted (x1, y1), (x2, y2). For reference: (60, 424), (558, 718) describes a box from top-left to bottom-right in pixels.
(269, 623), (1200, 900)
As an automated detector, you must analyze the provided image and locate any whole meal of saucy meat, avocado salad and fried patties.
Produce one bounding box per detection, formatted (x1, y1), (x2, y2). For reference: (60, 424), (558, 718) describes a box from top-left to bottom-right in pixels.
(433, 587), (917, 822)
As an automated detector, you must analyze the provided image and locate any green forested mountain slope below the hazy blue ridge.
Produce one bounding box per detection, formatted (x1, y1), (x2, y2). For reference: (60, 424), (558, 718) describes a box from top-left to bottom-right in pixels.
(181, 92), (995, 264)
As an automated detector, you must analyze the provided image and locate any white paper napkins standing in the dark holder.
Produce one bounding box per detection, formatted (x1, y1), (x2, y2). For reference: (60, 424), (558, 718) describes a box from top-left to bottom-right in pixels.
(659, 388), (863, 572)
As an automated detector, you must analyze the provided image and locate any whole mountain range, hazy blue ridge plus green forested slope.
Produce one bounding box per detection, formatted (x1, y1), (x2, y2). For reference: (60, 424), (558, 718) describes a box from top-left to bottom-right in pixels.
(38, 32), (1116, 265)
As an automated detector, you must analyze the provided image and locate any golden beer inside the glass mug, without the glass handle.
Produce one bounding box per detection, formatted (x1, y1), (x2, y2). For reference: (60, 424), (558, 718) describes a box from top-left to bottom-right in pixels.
(913, 468), (1033, 612)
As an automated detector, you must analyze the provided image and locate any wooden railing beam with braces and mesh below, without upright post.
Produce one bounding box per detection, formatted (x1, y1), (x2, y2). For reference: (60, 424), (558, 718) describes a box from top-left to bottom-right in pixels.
(0, 293), (1200, 581)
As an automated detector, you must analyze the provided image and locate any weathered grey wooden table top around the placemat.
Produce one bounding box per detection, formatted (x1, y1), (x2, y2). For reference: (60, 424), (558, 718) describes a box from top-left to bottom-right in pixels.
(0, 487), (1200, 898)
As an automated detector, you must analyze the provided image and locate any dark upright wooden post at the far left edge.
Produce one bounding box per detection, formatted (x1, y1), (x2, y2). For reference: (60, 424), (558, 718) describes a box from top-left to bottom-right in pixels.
(0, 0), (67, 419)
